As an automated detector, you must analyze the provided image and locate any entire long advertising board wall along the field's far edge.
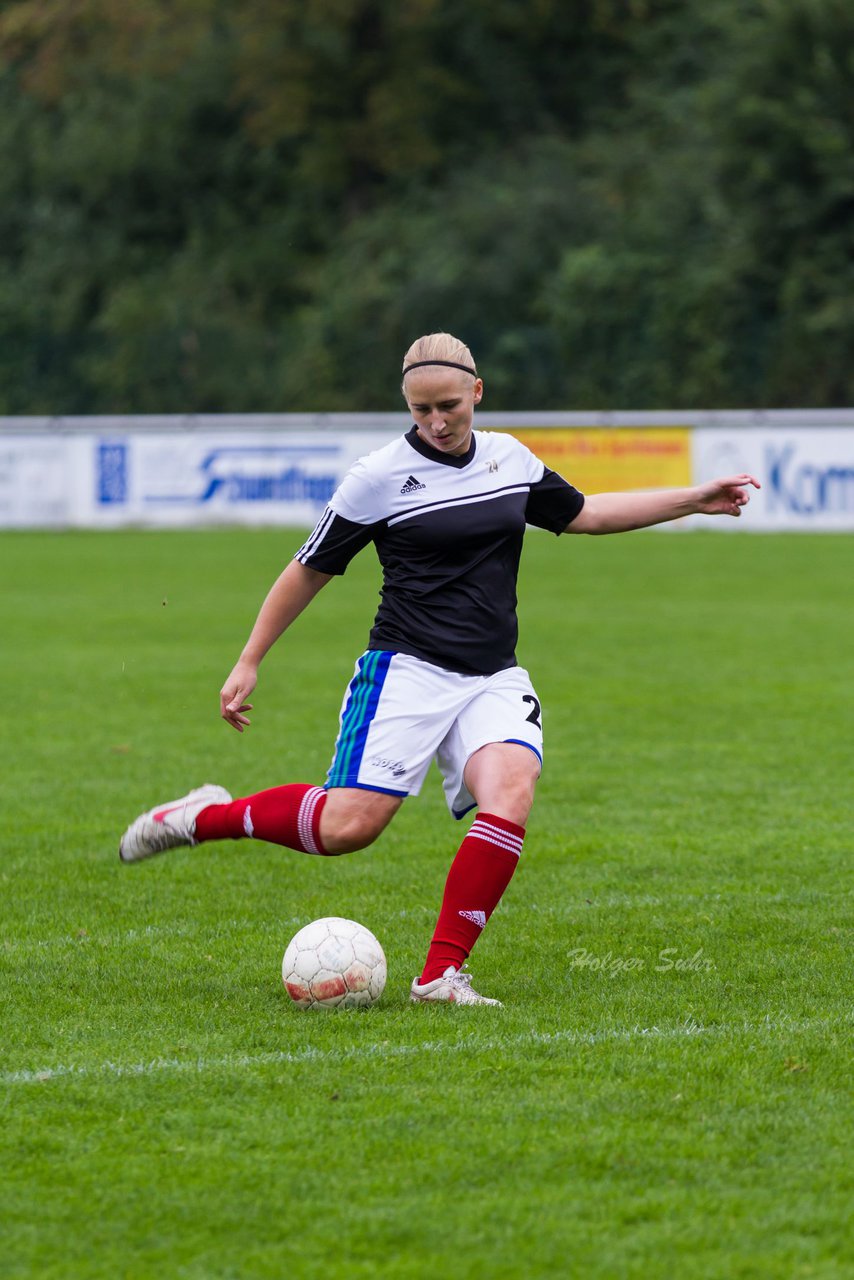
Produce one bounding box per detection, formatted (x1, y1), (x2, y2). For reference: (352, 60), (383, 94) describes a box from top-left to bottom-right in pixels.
(0, 410), (854, 531)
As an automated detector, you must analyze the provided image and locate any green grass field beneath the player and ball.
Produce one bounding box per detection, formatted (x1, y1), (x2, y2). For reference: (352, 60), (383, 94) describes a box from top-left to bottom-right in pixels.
(0, 517), (854, 1280)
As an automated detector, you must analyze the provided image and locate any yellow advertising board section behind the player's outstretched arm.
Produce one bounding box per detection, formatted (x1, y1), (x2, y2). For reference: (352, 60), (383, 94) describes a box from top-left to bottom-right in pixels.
(504, 426), (691, 493)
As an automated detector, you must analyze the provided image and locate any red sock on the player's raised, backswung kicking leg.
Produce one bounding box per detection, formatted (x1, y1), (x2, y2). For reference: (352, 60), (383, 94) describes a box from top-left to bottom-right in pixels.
(196, 782), (326, 854)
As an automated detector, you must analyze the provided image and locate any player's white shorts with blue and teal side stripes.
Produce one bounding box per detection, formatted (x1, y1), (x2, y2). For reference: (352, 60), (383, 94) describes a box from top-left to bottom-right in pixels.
(326, 650), (543, 818)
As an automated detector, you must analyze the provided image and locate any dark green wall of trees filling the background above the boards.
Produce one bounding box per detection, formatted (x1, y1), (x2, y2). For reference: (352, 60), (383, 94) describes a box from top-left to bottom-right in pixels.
(0, 0), (854, 413)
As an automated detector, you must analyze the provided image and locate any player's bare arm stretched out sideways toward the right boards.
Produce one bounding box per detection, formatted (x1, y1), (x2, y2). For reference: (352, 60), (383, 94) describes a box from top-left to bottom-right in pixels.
(565, 475), (761, 534)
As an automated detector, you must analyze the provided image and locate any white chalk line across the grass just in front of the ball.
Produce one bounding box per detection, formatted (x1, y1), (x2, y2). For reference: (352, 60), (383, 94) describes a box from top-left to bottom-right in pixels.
(0, 1010), (840, 1087)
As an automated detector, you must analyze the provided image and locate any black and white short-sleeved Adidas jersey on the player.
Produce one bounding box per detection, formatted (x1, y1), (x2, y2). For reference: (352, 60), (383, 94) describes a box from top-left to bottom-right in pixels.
(296, 428), (584, 675)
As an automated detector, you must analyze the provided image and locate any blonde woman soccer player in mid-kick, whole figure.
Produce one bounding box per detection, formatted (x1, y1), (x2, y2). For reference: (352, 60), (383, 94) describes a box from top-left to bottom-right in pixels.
(119, 333), (758, 1005)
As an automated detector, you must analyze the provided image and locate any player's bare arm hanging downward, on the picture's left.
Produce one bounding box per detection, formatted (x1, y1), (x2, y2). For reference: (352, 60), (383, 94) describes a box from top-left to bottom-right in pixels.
(219, 561), (332, 733)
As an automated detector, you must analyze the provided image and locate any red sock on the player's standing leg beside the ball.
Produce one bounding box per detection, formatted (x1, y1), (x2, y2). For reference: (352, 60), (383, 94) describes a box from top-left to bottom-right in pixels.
(421, 813), (525, 983)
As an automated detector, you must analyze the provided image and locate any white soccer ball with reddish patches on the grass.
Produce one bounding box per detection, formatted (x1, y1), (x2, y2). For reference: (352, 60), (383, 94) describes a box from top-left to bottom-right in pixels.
(282, 915), (385, 1009)
